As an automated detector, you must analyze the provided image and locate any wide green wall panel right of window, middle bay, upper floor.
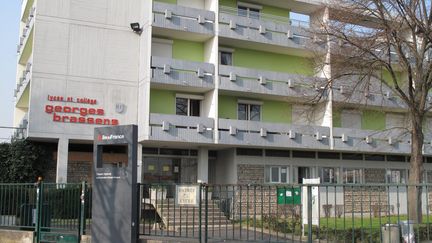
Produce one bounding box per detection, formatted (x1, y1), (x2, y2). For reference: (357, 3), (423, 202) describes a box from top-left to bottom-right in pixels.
(233, 48), (313, 76)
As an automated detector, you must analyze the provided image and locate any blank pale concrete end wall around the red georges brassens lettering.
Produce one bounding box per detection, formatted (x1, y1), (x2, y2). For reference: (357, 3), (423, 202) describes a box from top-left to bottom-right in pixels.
(28, 0), (141, 139)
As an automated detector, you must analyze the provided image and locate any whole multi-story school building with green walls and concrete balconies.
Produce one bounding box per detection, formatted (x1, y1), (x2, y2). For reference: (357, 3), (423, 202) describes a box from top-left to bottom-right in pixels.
(11, 0), (432, 186)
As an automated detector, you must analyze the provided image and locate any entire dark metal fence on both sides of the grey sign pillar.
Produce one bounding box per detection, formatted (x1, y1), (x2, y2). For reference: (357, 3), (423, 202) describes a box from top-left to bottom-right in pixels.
(0, 183), (432, 242)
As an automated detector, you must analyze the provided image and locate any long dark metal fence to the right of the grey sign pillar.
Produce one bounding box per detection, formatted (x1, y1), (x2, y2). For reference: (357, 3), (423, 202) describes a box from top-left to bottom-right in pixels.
(140, 184), (432, 242)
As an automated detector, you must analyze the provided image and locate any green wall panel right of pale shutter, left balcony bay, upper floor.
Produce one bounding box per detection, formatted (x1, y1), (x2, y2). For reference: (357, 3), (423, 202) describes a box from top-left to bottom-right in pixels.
(172, 39), (204, 62)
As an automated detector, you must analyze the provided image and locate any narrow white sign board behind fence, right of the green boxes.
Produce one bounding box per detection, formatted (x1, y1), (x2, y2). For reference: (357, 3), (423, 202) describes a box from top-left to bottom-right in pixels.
(301, 178), (320, 226)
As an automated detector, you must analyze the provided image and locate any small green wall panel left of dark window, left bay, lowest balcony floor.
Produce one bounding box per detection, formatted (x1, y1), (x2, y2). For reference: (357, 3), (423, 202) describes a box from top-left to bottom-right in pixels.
(150, 89), (175, 114)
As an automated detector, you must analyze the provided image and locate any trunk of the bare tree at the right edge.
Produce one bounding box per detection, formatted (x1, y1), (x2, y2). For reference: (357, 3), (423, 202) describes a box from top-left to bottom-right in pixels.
(407, 111), (423, 223)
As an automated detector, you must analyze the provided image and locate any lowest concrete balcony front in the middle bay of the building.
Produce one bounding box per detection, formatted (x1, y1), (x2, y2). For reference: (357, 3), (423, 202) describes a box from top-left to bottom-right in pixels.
(219, 119), (330, 149)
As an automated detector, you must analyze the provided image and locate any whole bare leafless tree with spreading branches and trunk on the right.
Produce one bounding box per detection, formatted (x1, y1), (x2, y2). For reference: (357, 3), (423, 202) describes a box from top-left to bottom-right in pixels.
(312, 0), (432, 222)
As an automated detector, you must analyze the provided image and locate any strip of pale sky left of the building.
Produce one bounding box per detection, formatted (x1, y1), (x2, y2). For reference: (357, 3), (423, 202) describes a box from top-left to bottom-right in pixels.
(0, 0), (21, 142)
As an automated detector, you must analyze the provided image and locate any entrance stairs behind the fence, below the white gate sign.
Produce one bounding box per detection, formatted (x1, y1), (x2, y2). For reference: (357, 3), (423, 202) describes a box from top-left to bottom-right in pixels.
(152, 198), (232, 231)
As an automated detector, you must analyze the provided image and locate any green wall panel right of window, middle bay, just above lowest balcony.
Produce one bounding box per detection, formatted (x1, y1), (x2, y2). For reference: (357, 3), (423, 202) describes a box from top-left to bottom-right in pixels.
(262, 100), (292, 123)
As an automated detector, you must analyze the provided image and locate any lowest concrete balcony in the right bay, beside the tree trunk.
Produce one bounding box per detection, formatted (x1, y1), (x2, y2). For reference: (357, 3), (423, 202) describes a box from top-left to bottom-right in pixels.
(333, 127), (411, 154)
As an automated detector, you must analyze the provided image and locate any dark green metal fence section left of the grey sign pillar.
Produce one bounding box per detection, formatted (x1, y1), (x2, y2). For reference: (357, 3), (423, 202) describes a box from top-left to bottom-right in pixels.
(0, 182), (91, 242)
